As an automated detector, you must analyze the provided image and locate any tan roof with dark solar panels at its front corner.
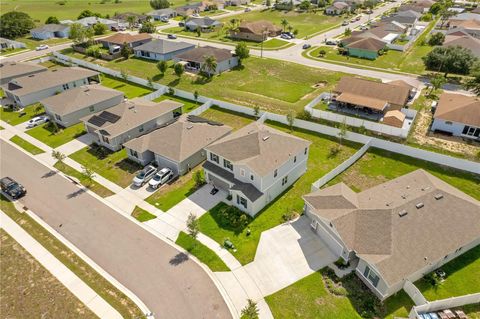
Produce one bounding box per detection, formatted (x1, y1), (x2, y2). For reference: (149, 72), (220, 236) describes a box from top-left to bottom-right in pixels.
(82, 98), (183, 137)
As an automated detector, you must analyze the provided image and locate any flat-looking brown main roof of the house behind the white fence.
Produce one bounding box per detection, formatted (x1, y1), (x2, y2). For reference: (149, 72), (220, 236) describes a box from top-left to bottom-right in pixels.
(333, 76), (410, 105)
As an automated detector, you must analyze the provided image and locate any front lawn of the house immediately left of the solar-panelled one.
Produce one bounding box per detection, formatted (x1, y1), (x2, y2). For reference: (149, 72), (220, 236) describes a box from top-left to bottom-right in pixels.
(26, 123), (86, 148)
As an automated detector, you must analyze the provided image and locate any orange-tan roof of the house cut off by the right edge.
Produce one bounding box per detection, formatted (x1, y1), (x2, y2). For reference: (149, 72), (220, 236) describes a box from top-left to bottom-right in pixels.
(433, 93), (480, 127)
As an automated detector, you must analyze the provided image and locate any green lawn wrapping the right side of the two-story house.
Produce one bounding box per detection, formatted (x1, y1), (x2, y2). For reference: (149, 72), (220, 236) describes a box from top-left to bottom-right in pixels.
(200, 123), (360, 265)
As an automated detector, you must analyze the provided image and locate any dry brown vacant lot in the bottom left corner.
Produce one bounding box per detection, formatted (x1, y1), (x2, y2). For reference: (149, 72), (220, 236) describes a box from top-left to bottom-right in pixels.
(0, 229), (97, 318)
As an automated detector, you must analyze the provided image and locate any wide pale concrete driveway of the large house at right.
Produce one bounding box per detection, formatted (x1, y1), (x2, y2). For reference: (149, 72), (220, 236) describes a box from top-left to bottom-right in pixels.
(244, 217), (335, 296)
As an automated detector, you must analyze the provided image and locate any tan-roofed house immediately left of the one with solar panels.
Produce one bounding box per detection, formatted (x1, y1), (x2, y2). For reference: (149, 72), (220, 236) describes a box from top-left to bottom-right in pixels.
(40, 84), (124, 127)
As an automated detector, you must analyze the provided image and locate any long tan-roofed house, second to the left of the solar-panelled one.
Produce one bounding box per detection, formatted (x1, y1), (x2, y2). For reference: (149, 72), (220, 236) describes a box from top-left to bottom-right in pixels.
(4, 67), (100, 106)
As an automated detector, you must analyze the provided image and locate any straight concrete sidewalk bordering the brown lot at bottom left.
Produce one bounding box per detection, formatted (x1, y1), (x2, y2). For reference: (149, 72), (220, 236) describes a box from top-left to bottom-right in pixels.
(0, 211), (122, 319)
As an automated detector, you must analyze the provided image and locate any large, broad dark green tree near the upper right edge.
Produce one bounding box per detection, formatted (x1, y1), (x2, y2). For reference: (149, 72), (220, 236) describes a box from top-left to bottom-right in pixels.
(422, 46), (476, 77)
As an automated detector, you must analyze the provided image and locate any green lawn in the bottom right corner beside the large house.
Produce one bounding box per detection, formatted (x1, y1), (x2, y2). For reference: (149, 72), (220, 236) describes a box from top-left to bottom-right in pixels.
(415, 246), (480, 301)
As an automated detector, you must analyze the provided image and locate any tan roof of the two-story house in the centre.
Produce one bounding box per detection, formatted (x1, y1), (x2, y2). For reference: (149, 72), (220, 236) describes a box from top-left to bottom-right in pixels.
(206, 122), (311, 176)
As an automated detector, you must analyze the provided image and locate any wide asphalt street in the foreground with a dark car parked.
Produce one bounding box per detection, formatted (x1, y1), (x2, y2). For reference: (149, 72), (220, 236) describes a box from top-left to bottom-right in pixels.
(0, 141), (231, 319)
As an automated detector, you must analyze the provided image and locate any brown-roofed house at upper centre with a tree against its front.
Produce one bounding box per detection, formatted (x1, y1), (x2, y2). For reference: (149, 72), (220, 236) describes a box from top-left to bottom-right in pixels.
(173, 46), (238, 74)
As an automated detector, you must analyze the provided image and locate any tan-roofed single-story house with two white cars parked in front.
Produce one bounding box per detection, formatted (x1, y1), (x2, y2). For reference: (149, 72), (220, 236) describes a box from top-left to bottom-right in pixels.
(124, 114), (232, 175)
